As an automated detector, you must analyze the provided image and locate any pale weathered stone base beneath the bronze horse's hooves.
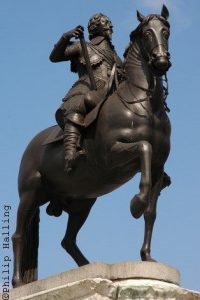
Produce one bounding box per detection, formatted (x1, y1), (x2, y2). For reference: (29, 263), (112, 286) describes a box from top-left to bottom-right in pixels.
(4, 262), (200, 300)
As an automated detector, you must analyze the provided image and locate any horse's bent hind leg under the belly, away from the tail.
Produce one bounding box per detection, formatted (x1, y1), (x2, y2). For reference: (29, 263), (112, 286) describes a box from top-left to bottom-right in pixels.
(61, 199), (96, 266)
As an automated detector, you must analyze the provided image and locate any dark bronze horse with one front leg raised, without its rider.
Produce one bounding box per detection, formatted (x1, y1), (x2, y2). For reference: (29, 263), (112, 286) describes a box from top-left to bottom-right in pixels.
(12, 6), (171, 287)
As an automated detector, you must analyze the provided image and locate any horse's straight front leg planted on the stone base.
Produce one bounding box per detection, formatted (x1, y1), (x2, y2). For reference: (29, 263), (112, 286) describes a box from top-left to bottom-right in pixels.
(140, 171), (171, 261)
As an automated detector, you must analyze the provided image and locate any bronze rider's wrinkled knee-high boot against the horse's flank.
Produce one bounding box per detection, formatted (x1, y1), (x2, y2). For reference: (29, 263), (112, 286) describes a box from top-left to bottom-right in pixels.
(63, 121), (85, 173)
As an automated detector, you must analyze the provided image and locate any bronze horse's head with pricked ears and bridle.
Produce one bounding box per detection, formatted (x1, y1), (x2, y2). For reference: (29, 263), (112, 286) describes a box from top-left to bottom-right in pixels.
(130, 5), (171, 76)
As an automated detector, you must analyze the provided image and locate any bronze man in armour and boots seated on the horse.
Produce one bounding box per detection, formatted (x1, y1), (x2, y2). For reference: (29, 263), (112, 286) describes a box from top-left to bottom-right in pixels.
(50, 13), (123, 172)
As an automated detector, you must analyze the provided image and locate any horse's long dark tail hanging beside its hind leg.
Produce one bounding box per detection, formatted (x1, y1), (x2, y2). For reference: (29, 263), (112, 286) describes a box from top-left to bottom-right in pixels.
(21, 208), (40, 283)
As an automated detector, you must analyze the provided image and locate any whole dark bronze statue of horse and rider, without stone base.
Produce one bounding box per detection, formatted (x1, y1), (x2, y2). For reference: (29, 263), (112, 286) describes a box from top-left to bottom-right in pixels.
(12, 5), (171, 287)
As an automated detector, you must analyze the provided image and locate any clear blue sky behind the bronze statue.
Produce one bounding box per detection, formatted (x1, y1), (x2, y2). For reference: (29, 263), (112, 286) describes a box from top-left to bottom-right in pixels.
(0, 0), (200, 290)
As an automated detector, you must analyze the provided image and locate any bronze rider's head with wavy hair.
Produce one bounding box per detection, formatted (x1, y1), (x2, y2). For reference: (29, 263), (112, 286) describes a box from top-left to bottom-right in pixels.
(88, 13), (113, 39)
